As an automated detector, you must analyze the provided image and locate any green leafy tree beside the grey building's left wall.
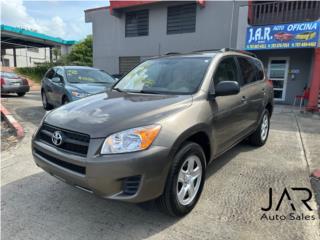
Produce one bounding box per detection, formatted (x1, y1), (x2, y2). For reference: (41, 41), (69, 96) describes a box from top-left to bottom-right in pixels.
(67, 35), (92, 66)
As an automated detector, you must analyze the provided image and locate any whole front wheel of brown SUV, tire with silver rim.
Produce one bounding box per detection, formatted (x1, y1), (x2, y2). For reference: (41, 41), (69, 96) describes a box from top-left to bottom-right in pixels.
(158, 142), (206, 217)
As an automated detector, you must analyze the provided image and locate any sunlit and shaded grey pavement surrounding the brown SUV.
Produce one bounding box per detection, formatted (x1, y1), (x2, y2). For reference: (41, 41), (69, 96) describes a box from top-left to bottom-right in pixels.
(1, 92), (320, 240)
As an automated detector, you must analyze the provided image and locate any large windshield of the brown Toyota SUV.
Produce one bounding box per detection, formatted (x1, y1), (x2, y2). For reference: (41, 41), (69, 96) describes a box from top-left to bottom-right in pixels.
(114, 57), (212, 94)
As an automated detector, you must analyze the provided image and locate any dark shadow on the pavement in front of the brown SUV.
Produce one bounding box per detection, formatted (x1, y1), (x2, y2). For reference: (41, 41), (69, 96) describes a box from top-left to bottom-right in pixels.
(1, 172), (179, 239)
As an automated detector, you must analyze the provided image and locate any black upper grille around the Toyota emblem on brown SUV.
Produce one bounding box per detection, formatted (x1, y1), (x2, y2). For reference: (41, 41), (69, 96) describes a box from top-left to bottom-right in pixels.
(37, 124), (90, 156)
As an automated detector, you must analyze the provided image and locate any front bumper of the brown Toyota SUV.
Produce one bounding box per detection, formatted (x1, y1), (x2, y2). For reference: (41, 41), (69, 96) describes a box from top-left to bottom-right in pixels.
(32, 139), (170, 203)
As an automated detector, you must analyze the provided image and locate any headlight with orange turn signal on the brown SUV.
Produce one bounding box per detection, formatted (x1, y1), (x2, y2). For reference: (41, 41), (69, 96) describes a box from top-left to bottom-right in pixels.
(101, 125), (161, 154)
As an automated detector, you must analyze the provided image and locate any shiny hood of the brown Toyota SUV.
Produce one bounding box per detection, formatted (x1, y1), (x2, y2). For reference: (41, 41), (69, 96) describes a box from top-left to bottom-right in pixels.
(45, 91), (192, 138)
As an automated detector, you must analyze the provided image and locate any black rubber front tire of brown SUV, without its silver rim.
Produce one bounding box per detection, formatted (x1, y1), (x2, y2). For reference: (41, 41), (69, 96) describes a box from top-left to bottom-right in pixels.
(157, 142), (206, 217)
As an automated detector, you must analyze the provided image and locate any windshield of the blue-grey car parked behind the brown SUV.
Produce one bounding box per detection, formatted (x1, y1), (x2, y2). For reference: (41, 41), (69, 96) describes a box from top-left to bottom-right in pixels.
(66, 68), (115, 84)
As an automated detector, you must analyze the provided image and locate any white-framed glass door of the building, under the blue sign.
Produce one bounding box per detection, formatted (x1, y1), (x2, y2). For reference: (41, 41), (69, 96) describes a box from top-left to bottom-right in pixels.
(268, 57), (289, 101)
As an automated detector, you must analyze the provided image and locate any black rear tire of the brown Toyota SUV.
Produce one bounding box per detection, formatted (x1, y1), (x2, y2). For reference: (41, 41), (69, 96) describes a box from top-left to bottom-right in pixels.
(249, 109), (270, 147)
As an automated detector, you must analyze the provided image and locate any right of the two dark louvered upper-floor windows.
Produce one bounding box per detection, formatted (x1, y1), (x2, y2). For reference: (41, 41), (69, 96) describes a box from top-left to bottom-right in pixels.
(167, 3), (197, 34)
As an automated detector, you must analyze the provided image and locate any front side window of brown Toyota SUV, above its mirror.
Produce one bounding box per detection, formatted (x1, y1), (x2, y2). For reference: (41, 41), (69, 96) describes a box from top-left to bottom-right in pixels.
(213, 57), (239, 85)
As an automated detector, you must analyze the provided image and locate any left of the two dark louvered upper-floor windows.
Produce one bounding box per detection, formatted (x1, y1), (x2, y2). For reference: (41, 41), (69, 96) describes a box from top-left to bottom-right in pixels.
(125, 10), (149, 37)
